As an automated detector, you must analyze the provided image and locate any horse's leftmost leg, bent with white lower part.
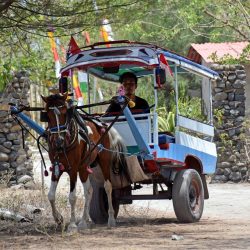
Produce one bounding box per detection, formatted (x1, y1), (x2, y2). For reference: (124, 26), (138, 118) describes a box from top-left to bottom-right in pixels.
(48, 177), (63, 225)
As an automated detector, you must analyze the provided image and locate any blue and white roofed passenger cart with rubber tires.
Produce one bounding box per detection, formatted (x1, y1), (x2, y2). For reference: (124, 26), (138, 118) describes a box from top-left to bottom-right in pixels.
(10, 41), (218, 229)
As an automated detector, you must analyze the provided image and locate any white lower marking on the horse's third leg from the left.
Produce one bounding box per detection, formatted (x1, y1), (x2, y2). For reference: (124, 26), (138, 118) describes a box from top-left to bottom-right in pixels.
(78, 177), (93, 230)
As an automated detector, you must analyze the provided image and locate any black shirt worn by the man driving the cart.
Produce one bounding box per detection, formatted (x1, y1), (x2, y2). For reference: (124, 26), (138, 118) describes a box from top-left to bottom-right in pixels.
(106, 96), (150, 113)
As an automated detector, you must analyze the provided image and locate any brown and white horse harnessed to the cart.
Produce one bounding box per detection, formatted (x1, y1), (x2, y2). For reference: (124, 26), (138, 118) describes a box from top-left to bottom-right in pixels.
(42, 93), (129, 232)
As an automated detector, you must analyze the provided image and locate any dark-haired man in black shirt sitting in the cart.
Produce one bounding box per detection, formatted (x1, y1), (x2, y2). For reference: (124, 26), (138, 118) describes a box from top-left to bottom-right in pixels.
(106, 72), (150, 113)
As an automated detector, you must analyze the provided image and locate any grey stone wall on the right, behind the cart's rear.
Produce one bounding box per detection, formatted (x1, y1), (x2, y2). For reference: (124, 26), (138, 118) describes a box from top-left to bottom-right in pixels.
(212, 65), (250, 182)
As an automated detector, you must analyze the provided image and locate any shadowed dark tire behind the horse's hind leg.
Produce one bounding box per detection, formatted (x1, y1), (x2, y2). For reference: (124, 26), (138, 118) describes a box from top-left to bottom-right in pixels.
(89, 180), (119, 224)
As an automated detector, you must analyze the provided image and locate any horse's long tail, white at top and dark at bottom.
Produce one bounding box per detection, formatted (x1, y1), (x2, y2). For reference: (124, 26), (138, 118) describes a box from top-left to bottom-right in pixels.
(109, 127), (130, 181)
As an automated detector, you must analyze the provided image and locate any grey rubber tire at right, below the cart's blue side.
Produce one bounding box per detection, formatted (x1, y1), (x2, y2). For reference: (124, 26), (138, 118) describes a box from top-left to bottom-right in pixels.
(172, 169), (204, 223)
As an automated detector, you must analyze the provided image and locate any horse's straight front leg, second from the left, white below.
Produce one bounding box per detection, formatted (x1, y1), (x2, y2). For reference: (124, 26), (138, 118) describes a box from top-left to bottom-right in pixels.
(67, 173), (77, 232)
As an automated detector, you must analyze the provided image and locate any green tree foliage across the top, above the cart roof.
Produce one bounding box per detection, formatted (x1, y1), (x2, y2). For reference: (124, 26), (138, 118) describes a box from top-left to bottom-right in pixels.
(0, 0), (250, 92)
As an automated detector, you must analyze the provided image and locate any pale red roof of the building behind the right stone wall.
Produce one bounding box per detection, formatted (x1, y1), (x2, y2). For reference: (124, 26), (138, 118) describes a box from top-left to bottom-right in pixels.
(187, 41), (249, 63)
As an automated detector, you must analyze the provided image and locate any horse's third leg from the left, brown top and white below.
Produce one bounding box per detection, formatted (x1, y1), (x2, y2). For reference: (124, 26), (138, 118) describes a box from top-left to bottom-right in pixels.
(78, 172), (93, 230)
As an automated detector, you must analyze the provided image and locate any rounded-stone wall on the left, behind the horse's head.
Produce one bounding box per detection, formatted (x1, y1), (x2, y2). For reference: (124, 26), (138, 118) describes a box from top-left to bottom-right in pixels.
(0, 71), (34, 188)
